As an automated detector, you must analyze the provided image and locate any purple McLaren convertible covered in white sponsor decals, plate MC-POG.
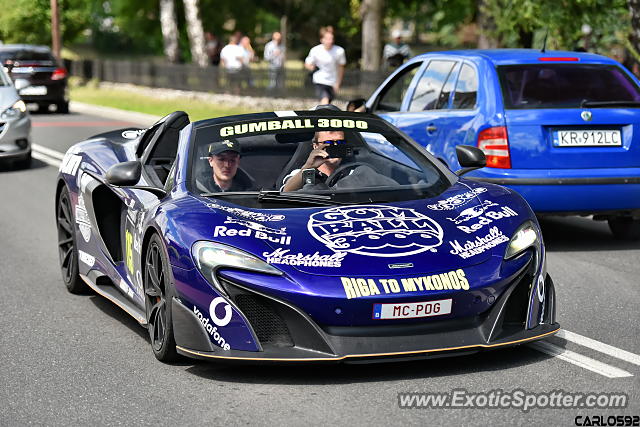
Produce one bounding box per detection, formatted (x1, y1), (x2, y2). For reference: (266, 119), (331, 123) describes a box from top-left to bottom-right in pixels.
(55, 109), (559, 362)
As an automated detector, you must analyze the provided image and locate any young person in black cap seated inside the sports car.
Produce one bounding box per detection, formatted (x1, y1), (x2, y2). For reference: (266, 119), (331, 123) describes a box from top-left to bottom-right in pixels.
(207, 139), (253, 193)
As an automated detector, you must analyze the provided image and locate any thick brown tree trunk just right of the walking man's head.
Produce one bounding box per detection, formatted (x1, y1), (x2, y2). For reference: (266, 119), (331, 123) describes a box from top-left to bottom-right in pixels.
(360, 0), (384, 71)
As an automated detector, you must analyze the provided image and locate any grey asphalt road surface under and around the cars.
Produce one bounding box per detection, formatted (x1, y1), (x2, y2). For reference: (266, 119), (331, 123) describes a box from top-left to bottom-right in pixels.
(0, 109), (640, 426)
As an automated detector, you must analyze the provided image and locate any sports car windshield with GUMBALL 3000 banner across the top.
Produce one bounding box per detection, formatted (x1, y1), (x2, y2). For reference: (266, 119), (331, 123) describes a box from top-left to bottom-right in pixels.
(189, 114), (454, 207)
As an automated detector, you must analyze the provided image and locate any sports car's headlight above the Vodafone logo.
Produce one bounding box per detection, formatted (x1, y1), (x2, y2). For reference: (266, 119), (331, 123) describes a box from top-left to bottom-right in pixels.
(192, 241), (282, 291)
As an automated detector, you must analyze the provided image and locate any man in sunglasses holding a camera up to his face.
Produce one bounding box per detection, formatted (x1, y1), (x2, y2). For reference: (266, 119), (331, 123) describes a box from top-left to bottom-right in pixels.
(280, 131), (344, 191)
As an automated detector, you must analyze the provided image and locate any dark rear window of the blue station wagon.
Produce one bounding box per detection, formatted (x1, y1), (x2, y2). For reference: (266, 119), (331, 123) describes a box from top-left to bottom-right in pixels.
(497, 64), (640, 110)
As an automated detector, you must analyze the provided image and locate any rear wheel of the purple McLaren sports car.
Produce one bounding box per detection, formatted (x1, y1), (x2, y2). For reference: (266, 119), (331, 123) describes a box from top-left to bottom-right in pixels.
(56, 185), (89, 294)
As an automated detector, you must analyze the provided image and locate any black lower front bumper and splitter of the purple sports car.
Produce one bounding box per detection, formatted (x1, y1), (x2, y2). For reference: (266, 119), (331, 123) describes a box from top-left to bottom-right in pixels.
(172, 270), (560, 363)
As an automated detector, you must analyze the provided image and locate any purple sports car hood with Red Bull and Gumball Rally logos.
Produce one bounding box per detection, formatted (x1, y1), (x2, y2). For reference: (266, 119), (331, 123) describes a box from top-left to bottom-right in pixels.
(188, 180), (532, 276)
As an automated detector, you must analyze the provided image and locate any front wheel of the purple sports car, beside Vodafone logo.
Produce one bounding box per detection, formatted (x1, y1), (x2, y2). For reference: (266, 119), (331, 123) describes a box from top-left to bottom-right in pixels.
(143, 234), (180, 362)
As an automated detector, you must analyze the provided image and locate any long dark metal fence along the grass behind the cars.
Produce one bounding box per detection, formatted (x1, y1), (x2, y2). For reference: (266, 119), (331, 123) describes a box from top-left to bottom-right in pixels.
(67, 60), (389, 100)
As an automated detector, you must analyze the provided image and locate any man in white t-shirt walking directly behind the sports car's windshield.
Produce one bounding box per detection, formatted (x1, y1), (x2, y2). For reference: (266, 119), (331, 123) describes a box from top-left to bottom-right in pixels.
(304, 27), (347, 104)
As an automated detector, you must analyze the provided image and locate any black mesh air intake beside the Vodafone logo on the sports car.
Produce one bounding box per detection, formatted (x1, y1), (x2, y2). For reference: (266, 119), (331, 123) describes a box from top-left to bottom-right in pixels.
(235, 294), (293, 347)
